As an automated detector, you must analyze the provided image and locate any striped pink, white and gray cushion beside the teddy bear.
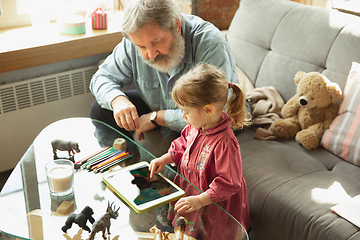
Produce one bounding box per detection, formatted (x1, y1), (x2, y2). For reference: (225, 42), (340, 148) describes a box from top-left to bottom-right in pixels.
(321, 62), (360, 166)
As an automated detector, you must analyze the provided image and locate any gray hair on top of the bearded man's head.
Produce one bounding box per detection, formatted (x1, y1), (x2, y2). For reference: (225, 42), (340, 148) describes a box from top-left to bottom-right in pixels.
(122, 0), (182, 38)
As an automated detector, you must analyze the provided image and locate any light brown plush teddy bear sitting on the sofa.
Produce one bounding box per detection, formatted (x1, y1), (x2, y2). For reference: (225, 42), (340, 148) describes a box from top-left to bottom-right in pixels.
(269, 71), (342, 150)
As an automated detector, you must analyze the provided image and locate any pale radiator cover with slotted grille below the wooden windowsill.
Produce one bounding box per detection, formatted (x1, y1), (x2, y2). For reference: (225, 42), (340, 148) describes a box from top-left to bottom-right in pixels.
(0, 65), (97, 172)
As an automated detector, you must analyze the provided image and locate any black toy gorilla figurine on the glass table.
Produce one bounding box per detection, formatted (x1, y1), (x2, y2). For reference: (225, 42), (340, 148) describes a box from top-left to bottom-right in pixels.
(61, 206), (95, 233)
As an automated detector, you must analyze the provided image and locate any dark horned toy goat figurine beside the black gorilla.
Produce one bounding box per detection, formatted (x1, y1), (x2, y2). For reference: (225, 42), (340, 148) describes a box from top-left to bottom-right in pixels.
(89, 202), (120, 240)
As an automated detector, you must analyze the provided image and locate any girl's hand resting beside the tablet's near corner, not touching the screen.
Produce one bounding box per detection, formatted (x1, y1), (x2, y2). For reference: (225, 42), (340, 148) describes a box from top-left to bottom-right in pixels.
(174, 192), (212, 213)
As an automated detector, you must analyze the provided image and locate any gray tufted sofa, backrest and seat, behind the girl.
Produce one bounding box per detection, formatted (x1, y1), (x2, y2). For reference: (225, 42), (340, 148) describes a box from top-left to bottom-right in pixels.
(226, 0), (360, 240)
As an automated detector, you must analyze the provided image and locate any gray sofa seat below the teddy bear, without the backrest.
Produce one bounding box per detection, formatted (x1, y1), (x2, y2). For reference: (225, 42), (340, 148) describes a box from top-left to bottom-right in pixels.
(236, 128), (360, 240)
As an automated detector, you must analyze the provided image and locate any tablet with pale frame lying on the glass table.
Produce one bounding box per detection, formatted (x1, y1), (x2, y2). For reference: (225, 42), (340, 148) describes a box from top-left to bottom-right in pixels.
(102, 162), (185, 213)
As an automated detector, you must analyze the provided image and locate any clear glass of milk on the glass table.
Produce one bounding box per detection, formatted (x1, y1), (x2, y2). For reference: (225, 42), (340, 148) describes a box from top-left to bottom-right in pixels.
(45, 159), (74, 199)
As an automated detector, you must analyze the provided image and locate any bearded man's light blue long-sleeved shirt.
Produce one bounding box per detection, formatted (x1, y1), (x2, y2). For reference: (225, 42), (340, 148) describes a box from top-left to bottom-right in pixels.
(90, 14), (238, 137)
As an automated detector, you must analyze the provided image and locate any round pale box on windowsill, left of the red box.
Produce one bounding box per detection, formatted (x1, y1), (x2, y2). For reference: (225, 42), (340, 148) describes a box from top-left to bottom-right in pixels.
(58, 15), (86, 34)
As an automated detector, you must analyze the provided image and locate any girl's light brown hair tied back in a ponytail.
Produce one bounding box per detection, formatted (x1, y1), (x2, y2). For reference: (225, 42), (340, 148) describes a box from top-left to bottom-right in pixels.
(172, 63), (250, 129)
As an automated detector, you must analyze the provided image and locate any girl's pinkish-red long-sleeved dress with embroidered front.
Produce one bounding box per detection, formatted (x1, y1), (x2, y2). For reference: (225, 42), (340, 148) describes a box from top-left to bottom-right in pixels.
(168, 112), (250, 240)
